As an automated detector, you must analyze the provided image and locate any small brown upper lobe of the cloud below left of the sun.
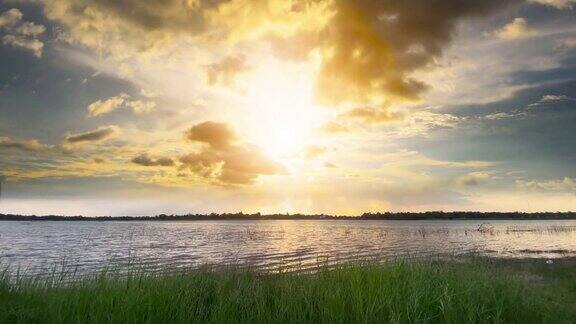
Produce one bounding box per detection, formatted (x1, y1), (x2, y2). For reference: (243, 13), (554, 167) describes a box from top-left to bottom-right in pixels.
(185, 121), (236, 150)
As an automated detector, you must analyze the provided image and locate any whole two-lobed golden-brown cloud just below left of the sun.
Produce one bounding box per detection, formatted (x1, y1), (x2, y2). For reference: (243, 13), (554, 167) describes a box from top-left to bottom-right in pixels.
(180, 121), (286, 185)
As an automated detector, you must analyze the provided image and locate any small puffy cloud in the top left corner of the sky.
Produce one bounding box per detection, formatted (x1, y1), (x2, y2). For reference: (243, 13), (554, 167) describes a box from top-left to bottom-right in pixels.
(0, 8), (46, 57)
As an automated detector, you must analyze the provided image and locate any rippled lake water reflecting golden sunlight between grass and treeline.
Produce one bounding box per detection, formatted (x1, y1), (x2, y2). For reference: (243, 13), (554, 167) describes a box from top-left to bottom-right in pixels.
(0, 220), (576, 274)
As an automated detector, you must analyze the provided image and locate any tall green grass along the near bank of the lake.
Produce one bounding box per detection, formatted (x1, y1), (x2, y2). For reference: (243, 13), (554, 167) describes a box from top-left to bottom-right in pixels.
(0, 260), (576, 323)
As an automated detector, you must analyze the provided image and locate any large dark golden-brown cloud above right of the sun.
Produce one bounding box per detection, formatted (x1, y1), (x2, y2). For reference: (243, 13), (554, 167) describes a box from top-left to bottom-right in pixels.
(316, 0), (511, 109)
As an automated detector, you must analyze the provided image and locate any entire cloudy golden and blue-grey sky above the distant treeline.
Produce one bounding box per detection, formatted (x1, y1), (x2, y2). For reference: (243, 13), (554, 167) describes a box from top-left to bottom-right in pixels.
(0, 0), (576, 216)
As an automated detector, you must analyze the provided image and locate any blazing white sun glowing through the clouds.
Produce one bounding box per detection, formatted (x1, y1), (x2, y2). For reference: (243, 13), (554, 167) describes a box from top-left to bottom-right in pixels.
(246, 60), (326, 159)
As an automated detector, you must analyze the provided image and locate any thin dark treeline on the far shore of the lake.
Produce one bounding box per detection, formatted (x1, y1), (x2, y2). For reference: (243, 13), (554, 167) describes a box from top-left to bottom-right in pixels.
(0, 212), (576, 221)
